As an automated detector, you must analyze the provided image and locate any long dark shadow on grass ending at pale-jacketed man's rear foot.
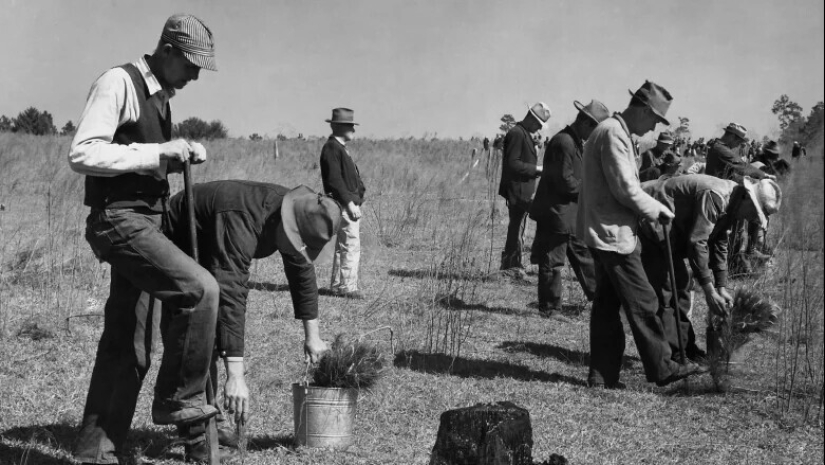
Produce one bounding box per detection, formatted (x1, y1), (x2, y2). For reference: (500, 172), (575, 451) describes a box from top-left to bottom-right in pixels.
(394, 351), (586, 386)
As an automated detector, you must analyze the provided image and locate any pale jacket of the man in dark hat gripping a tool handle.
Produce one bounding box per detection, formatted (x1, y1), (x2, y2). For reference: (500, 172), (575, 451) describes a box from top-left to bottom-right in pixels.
(576, 113), (661, 255)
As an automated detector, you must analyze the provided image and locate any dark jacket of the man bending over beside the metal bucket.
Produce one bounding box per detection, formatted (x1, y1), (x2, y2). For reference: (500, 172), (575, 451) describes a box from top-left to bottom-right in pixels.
(168, 181), (318, 357)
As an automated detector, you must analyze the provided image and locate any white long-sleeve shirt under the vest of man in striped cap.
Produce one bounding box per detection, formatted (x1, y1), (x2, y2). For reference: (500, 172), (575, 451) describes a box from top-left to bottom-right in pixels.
(69, 57), (174, 179)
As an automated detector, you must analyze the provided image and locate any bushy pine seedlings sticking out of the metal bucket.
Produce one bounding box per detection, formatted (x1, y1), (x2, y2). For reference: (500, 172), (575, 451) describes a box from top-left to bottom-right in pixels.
(312, 334), (388, 390)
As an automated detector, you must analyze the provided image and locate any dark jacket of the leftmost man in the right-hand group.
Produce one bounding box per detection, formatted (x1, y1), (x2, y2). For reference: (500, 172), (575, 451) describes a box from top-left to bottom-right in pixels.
(498, 123), (538, 209)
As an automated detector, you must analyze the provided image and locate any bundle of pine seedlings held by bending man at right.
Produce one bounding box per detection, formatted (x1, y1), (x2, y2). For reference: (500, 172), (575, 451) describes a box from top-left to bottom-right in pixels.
(707, 287), (782, 391)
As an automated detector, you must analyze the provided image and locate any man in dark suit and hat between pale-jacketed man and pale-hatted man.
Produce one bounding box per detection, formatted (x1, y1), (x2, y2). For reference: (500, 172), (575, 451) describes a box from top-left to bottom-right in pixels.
(530, 100), (610, 317)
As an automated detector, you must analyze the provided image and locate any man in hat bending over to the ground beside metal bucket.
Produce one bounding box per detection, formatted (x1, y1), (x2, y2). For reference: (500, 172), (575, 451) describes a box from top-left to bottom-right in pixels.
(163, 181), (341, 460)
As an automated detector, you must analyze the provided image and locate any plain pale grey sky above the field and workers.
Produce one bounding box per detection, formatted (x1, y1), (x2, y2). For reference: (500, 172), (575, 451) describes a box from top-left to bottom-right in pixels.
(0, 0), (825, 138)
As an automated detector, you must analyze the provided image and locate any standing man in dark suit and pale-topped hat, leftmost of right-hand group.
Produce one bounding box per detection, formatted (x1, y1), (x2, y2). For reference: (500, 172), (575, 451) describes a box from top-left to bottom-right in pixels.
(498, 102), (550, 270)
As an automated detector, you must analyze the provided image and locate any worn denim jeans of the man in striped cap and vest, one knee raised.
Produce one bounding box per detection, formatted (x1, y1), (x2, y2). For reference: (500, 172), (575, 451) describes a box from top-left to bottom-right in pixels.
(74, 209), (219, 464)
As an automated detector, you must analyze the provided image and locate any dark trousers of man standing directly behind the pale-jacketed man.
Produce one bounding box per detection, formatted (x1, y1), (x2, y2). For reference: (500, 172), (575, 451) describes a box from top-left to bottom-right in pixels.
(530, 220), (596, 310)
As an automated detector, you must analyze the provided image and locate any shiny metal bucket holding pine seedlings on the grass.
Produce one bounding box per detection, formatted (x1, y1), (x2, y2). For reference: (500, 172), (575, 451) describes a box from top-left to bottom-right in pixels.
(292, 383), (358, 449)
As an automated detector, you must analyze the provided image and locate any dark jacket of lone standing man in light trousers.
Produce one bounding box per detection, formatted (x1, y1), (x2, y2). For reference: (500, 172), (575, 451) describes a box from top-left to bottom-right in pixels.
(321, 136), (367, 207)
